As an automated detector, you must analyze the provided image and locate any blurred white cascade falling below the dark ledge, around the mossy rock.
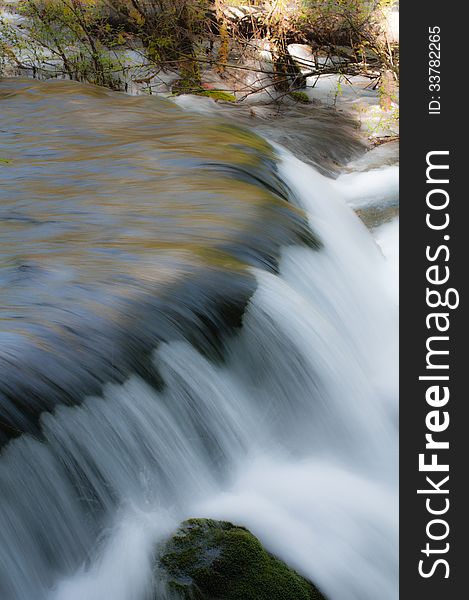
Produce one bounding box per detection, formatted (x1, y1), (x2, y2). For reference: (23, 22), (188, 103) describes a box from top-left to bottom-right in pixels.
(0, 150), (398, 600)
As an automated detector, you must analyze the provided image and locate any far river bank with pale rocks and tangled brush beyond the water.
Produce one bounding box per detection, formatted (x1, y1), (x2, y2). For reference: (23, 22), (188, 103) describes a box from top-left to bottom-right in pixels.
(0, 0), (399, 145)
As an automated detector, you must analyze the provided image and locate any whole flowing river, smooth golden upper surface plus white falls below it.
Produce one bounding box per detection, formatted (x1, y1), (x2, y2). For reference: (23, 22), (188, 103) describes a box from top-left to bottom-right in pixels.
(0, 80), (397, 600)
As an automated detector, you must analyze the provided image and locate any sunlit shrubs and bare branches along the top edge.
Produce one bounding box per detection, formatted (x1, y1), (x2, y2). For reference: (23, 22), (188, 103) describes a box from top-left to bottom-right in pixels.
(0, 0), (399, 102)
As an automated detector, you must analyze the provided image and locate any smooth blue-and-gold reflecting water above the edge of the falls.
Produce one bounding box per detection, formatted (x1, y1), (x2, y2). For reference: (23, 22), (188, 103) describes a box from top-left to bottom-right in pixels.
(0, 80), (317, 441)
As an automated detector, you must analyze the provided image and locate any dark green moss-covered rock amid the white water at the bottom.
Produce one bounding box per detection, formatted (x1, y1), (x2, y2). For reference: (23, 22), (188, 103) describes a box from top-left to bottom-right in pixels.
(160, 519), (324, 600)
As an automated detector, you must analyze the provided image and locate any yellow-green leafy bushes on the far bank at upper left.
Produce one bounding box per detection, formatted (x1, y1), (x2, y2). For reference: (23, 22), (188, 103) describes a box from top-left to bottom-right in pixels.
(0, 0), (210, 88)
